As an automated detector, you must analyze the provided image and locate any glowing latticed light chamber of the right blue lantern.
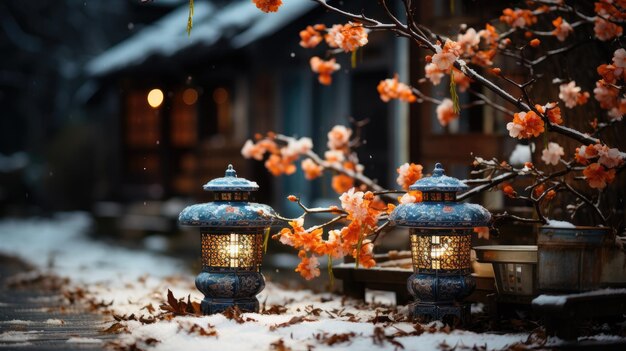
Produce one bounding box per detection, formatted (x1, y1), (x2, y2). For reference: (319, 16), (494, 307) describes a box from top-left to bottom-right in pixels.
(411, 228), (472, 273)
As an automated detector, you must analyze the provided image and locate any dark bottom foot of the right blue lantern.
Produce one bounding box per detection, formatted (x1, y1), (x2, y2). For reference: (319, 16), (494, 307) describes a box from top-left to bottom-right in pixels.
(408, 302), (471, 325)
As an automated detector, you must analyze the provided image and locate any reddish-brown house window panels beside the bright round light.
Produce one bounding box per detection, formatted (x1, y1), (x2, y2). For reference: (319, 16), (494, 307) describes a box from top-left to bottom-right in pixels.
(123, 87), (200, 196)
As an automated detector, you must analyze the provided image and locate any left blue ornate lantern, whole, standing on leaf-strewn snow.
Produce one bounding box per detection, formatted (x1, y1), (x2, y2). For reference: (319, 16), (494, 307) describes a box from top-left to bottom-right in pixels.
(178, 165), (275, 314)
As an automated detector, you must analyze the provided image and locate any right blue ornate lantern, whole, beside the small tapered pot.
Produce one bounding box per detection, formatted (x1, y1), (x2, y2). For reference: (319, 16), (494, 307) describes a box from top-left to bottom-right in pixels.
(390, 163), (491, 324)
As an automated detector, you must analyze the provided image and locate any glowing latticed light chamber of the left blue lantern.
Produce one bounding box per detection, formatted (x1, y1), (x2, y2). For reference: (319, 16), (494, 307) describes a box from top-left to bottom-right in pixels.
(202, 232), (263, 271)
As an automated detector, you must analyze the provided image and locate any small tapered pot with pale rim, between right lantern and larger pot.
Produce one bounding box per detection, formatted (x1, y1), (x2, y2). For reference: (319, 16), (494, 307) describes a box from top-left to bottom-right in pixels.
(474, 245), (537, 296)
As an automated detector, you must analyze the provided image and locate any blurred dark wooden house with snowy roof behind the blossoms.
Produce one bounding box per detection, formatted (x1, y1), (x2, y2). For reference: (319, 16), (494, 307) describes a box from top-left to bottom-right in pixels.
(86, 0), (510, 236)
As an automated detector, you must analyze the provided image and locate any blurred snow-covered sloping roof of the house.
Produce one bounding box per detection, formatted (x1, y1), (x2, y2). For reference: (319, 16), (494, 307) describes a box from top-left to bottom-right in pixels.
(86, 0), (315, 76)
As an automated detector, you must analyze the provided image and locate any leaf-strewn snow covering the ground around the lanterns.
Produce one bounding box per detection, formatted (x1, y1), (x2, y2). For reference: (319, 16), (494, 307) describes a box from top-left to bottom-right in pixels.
(0, 213), (528, 351)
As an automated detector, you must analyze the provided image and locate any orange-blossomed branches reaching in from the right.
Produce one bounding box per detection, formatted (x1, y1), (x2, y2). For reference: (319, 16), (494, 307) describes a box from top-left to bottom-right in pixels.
(242, 0), (626, 279)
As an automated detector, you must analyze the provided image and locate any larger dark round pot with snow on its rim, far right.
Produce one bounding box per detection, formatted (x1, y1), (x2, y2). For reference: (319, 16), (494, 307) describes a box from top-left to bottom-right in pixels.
(537, 227), (611, 293)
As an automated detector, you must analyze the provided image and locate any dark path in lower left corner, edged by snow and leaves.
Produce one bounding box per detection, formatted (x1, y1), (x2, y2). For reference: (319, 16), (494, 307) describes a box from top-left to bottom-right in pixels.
(0, 255), (115, 351)
